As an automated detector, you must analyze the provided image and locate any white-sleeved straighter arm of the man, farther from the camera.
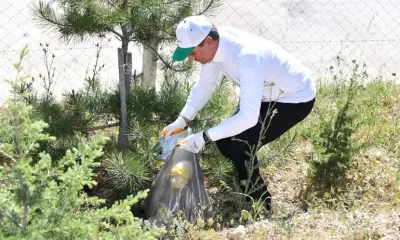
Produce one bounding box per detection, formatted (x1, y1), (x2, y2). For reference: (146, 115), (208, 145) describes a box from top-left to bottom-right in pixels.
(180, 63), (220, 123)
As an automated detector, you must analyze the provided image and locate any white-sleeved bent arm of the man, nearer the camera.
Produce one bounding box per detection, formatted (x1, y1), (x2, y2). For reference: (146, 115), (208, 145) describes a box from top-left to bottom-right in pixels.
(206, 55), (266, 141)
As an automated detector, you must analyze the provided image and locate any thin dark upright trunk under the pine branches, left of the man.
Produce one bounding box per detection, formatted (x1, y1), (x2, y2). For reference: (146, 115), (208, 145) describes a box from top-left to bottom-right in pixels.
(118, 48), (128, 150)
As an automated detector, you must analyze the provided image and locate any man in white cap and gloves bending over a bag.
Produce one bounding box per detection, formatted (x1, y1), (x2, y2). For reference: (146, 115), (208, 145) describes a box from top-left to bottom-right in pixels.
(161, 16), (316, 209)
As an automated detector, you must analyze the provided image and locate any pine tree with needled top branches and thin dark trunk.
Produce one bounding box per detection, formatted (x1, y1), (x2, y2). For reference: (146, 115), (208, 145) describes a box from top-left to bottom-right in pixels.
(34, 0), (219, 150)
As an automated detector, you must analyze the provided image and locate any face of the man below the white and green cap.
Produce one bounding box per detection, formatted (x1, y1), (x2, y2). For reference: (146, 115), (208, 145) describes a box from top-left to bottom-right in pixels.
(188, 37), (218, 64)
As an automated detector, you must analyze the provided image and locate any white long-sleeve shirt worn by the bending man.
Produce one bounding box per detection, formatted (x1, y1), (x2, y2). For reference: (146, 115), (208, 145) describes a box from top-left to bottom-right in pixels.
(180, 27), (316, 141)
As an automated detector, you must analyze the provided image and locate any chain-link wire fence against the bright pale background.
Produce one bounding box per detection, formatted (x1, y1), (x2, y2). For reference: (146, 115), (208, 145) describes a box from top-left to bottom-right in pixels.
(0, 0), (400, 102)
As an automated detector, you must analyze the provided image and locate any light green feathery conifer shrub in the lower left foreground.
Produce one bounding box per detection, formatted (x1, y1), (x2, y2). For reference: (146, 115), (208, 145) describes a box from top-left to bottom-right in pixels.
(0, 46), (165, 239)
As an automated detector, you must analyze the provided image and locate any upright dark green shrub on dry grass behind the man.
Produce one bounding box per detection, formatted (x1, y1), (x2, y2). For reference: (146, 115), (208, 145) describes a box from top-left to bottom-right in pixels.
(310, 63), (363, 191)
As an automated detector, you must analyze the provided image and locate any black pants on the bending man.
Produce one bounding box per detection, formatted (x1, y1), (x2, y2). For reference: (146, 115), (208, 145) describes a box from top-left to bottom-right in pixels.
(216, 99), (315, 208)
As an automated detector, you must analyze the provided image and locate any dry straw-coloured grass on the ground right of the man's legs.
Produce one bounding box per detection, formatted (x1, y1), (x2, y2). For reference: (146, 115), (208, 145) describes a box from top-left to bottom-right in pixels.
(186, 144), (400, 240)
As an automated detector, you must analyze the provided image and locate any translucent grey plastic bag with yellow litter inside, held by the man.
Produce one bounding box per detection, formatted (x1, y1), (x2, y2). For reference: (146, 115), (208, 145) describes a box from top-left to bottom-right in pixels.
(145, 129), (212, 225)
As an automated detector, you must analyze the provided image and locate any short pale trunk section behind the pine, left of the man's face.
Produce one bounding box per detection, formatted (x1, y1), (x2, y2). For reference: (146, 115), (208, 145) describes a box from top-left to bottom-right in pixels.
(142, 40), (158, 88)
